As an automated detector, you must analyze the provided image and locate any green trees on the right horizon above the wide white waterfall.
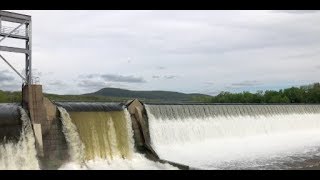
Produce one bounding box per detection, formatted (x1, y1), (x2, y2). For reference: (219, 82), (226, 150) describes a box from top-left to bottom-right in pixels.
(195, 83), (320, 103)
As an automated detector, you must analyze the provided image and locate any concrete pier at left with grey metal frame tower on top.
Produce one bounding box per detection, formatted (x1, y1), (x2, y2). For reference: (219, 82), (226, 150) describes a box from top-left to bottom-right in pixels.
(0, 10), (68, 168)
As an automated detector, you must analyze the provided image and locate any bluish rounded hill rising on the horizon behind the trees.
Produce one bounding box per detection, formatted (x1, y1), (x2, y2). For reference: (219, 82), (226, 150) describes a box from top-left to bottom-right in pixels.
(83, 88), (211, 102)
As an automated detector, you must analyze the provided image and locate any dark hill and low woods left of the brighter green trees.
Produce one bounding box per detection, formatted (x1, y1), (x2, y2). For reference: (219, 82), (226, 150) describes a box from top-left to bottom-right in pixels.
(0, 88), (211, 103)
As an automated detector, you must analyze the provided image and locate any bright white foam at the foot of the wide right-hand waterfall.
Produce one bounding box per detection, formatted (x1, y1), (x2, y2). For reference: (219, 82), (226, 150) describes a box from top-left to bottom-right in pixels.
(155, 131), (320, 169)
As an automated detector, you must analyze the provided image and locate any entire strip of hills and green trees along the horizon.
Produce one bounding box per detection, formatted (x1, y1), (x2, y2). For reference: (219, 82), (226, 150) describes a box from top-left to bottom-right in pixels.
(0, 83), (320, 104)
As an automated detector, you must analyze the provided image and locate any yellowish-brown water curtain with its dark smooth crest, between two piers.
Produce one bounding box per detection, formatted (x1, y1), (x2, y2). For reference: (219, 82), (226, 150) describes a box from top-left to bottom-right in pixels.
(58, 103), (133, 160)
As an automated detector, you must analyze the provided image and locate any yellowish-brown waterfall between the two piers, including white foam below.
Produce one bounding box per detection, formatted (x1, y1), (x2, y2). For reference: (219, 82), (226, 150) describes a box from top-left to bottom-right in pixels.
(58, 107), (177, 170)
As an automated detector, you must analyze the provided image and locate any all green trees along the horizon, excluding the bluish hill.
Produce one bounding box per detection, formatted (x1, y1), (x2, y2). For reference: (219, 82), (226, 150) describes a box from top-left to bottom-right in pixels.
(0, 83), (320, 103)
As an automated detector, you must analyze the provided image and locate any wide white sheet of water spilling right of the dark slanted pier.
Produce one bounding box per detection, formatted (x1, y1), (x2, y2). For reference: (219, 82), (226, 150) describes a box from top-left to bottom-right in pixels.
(146, 105), (320, 169)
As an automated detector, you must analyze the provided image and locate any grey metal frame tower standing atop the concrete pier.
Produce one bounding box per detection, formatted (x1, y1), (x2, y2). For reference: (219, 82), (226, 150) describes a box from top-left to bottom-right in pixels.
(0, 11), (32, 85)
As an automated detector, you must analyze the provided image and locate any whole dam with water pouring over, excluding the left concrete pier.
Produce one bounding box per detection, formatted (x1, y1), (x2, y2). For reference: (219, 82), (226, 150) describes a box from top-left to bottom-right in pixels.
(0, 100), (320, 169)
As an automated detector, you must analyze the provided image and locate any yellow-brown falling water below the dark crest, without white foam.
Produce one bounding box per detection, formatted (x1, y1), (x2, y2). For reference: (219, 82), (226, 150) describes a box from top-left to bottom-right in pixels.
(66, 111), (133, 160)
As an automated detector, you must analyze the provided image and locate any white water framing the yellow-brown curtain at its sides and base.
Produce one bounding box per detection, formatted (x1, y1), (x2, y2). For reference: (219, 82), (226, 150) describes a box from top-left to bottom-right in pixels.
(58, 107), (177, 170)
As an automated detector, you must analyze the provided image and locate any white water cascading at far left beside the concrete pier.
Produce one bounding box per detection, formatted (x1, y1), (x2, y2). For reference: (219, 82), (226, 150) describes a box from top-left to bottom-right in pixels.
(0, 108), (39, 170)
